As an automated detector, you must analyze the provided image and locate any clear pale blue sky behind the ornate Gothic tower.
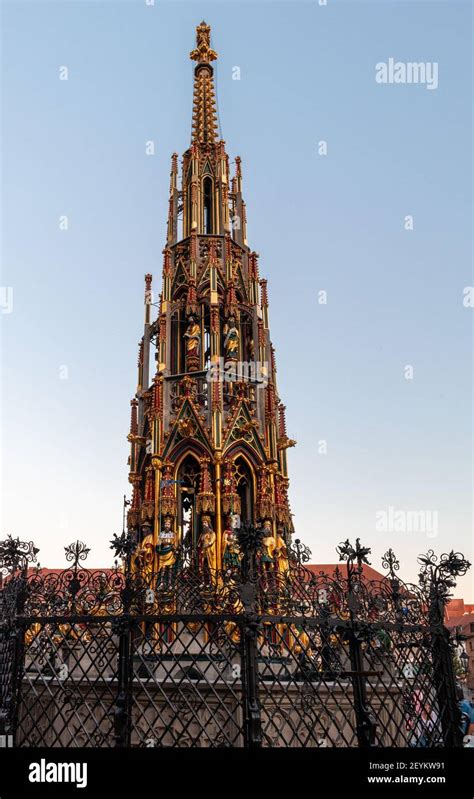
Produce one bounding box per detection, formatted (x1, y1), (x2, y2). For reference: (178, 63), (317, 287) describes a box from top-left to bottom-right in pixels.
(1, 0), (474, 600)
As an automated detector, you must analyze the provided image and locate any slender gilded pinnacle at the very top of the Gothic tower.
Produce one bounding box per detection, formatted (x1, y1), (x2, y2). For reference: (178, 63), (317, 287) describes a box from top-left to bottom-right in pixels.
(189, 21), (217, 144)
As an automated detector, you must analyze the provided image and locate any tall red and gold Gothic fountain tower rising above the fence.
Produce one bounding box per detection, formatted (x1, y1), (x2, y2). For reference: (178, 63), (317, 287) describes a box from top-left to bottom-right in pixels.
(128, 22), (294, 584)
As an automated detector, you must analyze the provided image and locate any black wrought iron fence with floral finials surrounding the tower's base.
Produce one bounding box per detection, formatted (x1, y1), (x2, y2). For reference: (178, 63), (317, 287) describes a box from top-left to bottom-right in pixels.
(0, 527), (469, 747)
